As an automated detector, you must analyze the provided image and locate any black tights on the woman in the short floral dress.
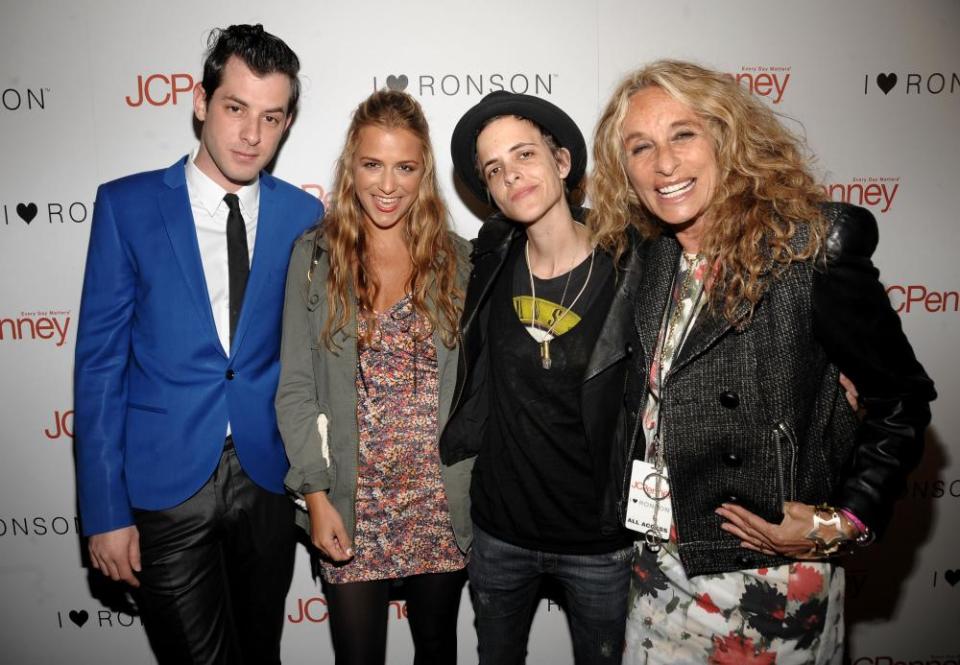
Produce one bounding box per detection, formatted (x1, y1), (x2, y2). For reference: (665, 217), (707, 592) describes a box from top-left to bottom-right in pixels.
(324, 570), (467, 665)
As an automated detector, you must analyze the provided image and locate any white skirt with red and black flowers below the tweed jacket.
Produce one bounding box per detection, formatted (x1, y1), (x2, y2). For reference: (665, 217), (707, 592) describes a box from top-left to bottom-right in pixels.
(623, 543), (844, 665)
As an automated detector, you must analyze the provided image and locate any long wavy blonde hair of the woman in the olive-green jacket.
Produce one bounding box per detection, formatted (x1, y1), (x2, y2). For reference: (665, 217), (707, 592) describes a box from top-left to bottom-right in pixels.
(315, 90), (463, 349)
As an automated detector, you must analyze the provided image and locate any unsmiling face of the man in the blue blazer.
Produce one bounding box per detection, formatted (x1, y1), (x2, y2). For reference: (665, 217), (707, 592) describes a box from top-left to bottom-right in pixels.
(193, 56), (291, 192)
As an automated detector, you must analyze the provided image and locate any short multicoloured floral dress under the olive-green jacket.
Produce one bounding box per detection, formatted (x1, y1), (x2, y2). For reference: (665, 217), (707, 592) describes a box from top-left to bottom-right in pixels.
(321, 297), (466, 584)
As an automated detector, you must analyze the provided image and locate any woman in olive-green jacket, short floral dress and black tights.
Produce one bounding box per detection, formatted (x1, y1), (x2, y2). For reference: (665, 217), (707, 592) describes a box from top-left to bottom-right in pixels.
(276, 91), (472, 664)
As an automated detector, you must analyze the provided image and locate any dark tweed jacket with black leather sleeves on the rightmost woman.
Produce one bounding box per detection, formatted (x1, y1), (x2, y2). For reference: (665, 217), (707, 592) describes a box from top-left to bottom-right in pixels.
(619, 204), (936, 576)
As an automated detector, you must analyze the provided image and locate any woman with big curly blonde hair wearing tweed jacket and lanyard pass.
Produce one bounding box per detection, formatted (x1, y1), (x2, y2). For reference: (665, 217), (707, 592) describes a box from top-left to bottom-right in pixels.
(591, 61), (935, 663)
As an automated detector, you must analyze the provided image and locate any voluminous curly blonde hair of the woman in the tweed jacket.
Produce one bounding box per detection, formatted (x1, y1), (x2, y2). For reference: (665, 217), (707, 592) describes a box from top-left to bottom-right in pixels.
(590, 60), (827, 325)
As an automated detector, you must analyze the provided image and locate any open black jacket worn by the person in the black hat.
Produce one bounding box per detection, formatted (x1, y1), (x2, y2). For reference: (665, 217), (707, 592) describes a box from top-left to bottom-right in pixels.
(440, 209), (638, 535)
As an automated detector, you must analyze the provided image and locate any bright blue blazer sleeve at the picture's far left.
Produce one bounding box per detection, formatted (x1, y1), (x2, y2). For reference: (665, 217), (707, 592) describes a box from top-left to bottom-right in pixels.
(73, 187), (137, 536)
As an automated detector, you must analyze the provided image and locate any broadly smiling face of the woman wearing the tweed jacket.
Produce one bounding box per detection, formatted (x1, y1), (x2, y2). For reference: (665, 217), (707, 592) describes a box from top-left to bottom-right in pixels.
(621, 87), (719, 252)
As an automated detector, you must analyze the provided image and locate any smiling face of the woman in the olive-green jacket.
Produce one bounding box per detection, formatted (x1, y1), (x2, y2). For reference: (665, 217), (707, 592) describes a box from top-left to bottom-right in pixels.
(353, 125), (424, 230)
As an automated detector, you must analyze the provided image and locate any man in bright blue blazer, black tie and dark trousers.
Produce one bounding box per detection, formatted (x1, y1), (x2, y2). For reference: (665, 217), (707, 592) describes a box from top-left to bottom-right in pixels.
(74, 25), (323, 665)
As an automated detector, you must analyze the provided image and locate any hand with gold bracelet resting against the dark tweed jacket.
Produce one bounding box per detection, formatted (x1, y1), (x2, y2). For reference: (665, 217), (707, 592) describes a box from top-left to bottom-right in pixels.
(716, 501), (856, 559)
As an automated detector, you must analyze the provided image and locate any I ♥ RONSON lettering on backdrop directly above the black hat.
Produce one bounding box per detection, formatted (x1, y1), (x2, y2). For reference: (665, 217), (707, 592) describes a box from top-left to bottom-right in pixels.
(373, 72), (559, 97)
